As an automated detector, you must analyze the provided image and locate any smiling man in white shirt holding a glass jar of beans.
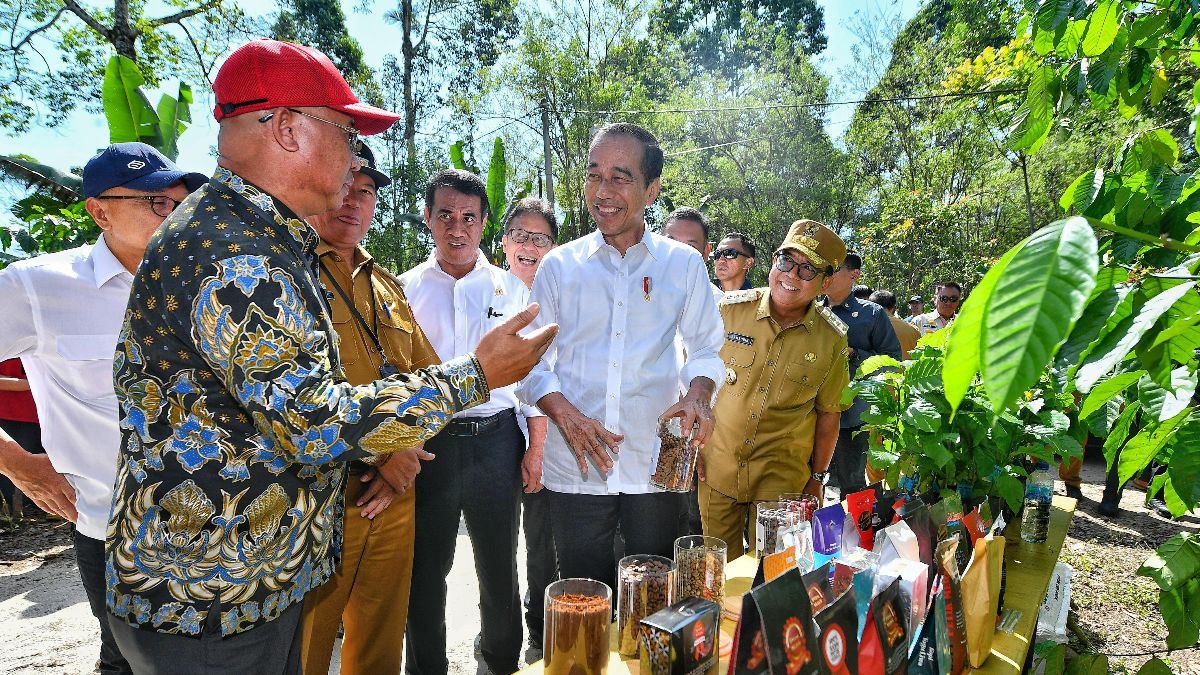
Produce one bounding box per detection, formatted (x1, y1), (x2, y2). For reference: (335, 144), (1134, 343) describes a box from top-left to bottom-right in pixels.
(517, 124), (725, 586)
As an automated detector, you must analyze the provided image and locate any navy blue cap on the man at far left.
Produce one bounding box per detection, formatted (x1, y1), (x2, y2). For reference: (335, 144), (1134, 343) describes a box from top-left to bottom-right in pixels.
(83, 142), (209, 197)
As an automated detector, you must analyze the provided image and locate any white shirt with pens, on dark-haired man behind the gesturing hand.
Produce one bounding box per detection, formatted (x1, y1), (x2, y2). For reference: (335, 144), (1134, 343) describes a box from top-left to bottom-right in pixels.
(400, 251), (541, 419)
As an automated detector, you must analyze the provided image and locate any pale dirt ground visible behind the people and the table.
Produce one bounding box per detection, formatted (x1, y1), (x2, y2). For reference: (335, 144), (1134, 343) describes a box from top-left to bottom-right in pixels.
(0, 449), (1200, 675)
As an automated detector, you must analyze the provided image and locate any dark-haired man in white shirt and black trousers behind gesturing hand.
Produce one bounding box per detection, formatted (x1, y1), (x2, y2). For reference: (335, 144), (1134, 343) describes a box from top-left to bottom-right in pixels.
(400, 169), (541, 674)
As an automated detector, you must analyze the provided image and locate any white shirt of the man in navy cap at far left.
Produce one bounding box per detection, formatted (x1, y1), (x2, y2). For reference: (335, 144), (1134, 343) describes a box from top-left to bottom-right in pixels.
(0, 237), (133, 540)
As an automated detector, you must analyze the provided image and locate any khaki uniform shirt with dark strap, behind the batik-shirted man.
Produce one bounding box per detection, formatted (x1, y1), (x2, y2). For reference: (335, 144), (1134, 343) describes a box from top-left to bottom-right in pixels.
(317, 241), (440, 384)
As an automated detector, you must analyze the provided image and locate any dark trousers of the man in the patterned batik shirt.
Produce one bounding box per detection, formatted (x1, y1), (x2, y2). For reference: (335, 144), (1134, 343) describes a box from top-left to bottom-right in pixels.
(109, 588), (304, 675)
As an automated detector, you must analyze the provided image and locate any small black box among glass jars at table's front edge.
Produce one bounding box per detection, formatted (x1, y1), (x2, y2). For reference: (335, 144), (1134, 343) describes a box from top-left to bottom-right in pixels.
(641, 598), (721, 675)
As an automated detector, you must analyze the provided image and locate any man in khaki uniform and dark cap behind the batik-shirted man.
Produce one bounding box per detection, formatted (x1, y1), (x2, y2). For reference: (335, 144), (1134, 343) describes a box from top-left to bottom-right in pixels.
(302, 145), (440, 674)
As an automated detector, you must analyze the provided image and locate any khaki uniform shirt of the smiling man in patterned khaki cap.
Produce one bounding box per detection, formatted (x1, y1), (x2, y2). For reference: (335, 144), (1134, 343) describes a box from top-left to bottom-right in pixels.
(703, 288), (850, 502)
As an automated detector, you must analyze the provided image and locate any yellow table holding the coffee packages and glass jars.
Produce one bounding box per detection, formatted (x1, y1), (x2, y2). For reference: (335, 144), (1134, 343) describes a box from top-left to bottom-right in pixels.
(521, 497), (1075, 675)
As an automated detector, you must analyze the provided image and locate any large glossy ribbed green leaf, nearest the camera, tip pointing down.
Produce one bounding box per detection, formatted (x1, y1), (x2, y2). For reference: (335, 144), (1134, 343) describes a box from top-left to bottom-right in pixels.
(984, 217), (1099, 411)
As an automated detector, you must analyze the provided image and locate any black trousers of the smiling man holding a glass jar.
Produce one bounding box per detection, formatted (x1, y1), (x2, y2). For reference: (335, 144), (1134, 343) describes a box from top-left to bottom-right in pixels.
(547, 490), (683, 593)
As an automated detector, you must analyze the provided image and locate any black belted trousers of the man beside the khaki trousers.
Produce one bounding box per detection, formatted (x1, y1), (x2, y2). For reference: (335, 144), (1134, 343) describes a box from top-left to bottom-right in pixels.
(404, 411), (524, 675)
